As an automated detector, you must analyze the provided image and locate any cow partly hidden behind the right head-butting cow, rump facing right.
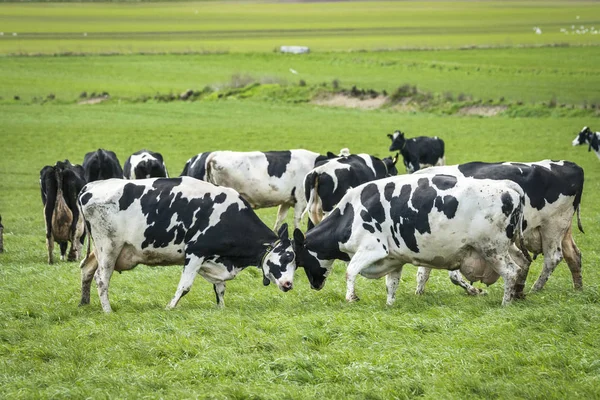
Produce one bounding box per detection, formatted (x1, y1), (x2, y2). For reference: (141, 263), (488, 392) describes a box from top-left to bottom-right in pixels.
(417, 160), (584, 294)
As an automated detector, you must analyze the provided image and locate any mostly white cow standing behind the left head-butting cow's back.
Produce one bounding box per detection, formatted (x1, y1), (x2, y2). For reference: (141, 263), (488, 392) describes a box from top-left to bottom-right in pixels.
(182, 149), (327, 230)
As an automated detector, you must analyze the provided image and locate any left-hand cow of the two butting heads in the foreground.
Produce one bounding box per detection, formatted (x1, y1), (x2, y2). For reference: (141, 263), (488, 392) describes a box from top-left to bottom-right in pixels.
(78, 177), (296, 312)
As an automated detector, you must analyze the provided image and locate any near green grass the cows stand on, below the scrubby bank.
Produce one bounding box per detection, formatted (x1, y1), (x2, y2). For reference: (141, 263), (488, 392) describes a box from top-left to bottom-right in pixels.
(0, 100), (600, 399)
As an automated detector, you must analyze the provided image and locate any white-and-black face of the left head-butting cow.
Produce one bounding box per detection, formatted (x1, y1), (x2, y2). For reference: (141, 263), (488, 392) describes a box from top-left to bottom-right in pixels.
(261, 224), (296, 292)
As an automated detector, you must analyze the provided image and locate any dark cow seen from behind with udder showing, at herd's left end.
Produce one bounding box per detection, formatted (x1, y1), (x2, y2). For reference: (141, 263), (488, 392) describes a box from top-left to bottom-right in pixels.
(40, 160), (86, 264)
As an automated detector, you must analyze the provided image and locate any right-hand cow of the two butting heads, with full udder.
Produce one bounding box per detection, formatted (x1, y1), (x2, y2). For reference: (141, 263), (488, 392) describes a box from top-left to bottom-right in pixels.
(294, 174), (529, 305)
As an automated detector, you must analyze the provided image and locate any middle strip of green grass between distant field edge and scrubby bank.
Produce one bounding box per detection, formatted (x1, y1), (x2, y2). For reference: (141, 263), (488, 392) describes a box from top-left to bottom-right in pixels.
(0, 46), (600, 105)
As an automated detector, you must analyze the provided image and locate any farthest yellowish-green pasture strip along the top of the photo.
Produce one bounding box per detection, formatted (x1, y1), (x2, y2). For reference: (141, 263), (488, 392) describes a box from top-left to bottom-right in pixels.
(0, 1), (600, 54)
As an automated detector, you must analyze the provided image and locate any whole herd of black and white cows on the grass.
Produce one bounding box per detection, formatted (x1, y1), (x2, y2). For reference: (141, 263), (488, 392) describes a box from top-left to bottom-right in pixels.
(31, 127), (600, 312)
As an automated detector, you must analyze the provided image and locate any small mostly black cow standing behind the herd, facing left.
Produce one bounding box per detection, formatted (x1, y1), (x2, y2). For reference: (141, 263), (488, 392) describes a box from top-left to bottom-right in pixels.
(388, 131), (446, 174)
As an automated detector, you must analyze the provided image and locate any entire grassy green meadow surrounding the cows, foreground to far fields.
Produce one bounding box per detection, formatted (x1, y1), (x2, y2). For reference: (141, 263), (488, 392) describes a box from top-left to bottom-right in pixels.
(0, 1), (600, 399)
